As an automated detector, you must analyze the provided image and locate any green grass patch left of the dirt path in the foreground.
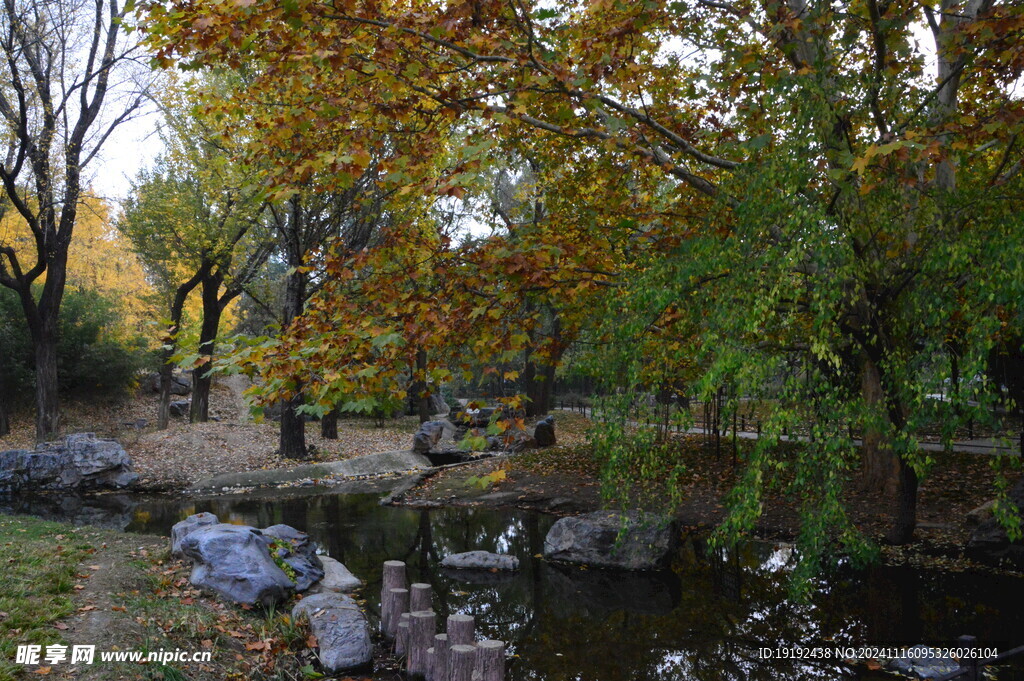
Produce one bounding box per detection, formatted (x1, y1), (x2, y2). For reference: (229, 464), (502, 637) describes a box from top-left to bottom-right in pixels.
(0, 516), (92, 681)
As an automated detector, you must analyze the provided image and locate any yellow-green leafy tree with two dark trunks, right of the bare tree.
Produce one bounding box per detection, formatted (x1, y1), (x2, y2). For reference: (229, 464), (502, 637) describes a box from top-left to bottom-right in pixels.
(119, 83), (274, 428)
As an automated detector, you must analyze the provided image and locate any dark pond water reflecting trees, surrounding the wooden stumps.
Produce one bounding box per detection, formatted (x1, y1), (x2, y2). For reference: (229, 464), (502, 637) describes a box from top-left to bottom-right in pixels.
(6, 483), (1024, 681)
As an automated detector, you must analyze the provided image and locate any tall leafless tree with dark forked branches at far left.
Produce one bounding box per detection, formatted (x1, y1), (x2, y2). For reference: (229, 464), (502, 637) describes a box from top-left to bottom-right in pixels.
(0, 0), (148, 440)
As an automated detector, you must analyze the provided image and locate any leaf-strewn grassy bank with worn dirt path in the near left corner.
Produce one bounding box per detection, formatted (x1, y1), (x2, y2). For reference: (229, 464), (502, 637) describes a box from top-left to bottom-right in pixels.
(0, 516), (318, 681)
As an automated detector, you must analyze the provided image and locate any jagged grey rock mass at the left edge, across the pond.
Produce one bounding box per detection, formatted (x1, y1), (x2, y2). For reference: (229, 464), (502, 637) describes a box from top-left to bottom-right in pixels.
(0, 433), (138, 493)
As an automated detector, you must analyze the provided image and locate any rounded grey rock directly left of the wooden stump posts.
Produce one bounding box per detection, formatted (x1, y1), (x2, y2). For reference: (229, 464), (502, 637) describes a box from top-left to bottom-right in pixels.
(292, 591), (373, 673)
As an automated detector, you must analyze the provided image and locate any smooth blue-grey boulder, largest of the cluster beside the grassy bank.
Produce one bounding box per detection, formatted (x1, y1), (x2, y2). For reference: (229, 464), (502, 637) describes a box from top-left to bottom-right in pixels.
(181, 523), (295, 605)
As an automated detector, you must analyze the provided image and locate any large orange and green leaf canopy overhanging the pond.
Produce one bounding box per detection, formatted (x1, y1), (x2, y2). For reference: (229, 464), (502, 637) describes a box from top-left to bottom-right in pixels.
(144, 0), (1024, 564)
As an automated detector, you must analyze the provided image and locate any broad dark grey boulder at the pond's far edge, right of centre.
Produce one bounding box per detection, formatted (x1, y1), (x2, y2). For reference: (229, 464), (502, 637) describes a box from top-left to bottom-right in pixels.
(544, 511), (679, 569)
